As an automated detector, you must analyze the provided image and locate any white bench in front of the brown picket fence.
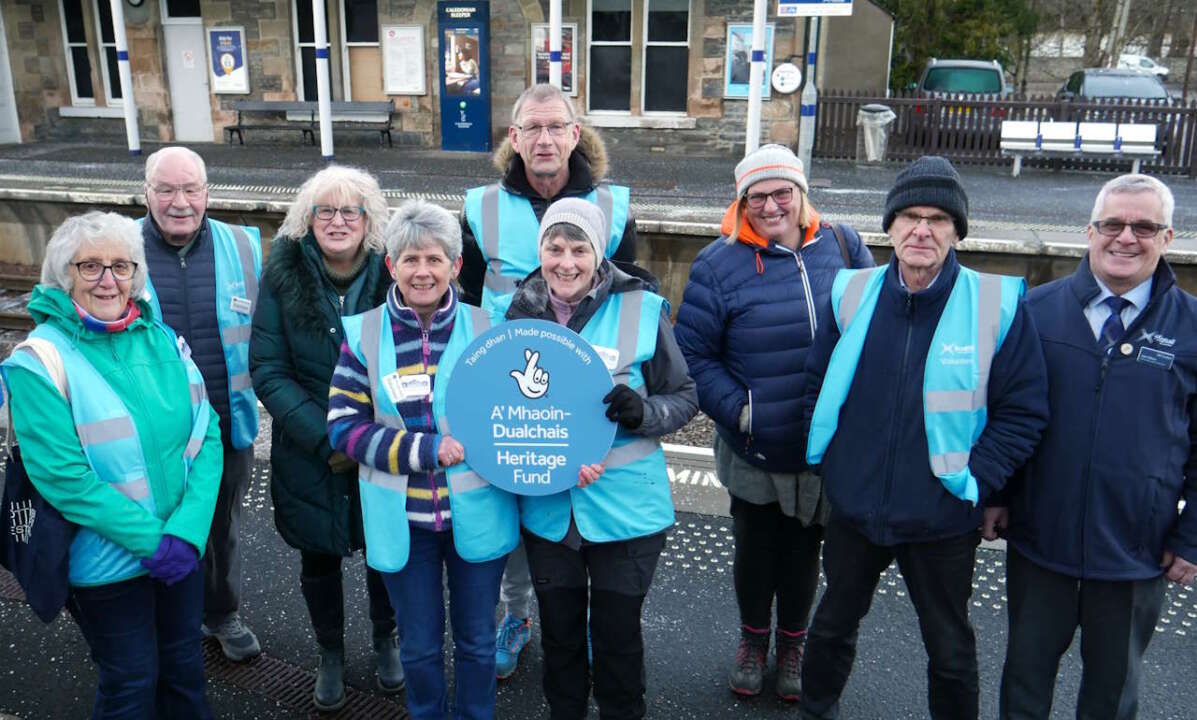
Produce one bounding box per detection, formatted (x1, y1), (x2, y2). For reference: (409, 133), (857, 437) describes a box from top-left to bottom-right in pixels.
(1001, 120), (1160, 177)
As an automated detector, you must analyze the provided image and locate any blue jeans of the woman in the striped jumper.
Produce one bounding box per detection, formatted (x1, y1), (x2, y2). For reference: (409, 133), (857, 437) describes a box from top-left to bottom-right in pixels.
(382, 527), (506, 720)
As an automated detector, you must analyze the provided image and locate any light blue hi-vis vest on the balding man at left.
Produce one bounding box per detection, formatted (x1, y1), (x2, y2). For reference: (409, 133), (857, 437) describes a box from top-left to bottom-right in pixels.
(141, 218), (262, 450)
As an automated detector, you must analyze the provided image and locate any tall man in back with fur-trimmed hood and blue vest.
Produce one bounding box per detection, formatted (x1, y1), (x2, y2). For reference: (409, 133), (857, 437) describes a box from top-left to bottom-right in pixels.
(458, 84), (643, 678)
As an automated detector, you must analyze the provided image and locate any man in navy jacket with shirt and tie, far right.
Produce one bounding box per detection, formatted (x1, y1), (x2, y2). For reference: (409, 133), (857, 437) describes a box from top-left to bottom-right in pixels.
(985, 175), (1197, 720)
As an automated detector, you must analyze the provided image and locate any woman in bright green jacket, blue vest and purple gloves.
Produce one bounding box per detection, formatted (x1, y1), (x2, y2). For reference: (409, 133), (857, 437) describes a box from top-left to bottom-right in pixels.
(0, 212), (223, 718)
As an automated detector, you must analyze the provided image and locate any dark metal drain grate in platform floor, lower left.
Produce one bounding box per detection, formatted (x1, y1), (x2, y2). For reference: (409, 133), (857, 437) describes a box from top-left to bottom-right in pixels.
(0, 568), (411, 720)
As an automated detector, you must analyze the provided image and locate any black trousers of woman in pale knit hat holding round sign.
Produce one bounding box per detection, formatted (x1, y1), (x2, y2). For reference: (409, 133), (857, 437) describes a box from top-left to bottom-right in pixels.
(524, 532), (666, 720)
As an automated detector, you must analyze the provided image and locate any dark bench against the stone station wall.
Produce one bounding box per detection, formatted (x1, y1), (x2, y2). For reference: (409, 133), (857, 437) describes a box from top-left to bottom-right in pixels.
(224, 100), (395, 147)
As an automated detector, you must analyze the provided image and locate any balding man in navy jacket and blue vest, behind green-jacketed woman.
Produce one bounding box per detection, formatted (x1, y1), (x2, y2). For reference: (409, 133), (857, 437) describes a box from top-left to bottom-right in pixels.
(141, 147), (262, 661)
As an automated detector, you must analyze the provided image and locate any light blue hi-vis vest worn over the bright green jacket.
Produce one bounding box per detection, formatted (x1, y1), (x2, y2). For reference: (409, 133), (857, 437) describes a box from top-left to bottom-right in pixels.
(5, 321), (212, 585)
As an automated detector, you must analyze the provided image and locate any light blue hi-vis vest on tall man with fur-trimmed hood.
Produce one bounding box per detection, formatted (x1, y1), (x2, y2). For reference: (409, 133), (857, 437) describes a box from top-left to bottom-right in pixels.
(466, 183), (631, 315)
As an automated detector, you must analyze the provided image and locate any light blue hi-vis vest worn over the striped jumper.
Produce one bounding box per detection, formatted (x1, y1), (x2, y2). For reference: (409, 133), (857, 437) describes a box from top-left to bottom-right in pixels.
(342, 303), (519, 573)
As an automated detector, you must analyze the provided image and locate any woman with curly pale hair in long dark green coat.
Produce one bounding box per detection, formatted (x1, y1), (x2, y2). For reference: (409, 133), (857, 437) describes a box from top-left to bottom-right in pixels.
(249, 165), (403, 710)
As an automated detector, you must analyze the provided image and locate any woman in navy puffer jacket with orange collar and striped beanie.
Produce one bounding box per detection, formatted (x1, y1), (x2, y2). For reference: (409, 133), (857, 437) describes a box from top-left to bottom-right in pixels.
(676, 145), (873, 701)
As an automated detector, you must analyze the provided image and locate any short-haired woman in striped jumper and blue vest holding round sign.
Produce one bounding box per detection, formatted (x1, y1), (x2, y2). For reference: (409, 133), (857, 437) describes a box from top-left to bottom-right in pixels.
(328, 201), (519, 720)
